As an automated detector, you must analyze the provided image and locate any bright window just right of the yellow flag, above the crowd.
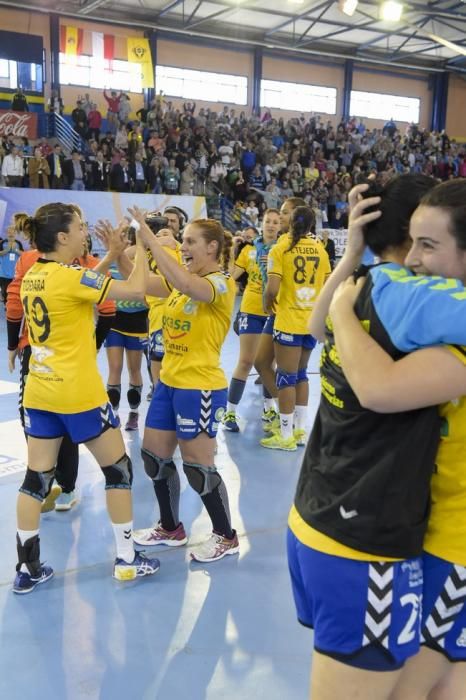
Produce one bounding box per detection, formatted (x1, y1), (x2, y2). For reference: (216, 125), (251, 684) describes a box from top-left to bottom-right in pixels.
(155, 66), (248, 105)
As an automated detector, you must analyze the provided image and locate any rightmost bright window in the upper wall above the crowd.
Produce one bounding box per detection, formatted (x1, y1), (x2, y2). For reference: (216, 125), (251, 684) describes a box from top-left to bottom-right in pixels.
(350, 90), (421, 124)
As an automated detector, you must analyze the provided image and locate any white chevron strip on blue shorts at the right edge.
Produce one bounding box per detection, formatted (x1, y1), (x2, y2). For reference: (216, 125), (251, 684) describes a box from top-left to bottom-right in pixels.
(421, 565), (466, 649)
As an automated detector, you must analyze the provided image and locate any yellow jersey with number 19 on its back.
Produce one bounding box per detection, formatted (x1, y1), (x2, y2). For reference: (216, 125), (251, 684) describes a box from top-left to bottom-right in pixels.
(20, 259), (112, 413)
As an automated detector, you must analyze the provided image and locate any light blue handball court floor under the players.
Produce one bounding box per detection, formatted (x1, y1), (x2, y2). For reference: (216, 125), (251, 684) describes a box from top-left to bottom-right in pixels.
(0, 308), (319, 700)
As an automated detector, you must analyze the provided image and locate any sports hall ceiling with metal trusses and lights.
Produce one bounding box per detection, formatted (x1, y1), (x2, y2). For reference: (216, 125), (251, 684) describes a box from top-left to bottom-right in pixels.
(0, 0), (466, 73)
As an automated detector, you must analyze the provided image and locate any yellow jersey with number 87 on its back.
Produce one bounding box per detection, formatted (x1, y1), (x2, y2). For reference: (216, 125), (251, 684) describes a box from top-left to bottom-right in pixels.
(267, 234), (331, 335)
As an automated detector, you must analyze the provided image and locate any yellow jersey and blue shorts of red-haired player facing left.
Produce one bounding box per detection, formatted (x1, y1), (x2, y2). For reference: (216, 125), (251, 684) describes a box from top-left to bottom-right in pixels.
(146, 272), (236, 440)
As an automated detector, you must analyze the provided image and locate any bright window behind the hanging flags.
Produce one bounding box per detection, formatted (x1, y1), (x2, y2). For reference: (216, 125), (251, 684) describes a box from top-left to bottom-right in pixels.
(60, 53), (142, 93)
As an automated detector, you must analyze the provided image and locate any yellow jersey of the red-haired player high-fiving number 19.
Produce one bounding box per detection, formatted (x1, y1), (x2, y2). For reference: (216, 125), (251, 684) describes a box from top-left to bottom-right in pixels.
(160, 272), (236, 391)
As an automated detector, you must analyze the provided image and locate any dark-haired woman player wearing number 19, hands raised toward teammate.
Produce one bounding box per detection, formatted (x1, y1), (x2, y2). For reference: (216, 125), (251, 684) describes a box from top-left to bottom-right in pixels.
(13, 203), (159, 594)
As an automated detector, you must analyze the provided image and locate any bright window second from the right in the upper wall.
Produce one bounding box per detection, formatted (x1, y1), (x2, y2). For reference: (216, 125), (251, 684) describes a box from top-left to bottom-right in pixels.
(261, 80), (337, 114)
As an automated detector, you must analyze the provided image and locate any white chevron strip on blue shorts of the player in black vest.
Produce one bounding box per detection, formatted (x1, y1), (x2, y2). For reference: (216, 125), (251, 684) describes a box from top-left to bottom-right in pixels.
(362, 562), (394, 649)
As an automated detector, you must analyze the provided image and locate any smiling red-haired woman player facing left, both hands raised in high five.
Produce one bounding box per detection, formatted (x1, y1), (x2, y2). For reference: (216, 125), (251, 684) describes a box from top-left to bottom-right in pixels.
(129, 207), (239, 562)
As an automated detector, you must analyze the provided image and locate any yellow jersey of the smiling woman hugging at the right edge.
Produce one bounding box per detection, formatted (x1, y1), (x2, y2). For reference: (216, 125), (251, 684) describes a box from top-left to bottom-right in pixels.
(424, 346), (466, 566)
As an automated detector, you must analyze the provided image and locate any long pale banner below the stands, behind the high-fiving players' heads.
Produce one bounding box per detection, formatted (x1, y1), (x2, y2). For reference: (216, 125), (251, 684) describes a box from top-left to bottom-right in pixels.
(0, 187), (207, 254)
